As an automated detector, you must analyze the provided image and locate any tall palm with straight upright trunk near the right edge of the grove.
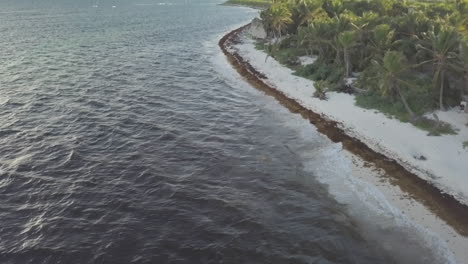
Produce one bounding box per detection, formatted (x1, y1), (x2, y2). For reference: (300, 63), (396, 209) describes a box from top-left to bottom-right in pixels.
(418, 26), (460, 110)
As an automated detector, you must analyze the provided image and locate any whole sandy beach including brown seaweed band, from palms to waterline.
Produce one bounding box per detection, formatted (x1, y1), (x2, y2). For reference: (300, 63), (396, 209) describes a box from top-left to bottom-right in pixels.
(220, 23), (468, 263)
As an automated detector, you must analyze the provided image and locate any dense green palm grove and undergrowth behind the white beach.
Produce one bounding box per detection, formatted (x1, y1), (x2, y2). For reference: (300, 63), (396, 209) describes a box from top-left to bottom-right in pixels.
(257, 0), (468, 135)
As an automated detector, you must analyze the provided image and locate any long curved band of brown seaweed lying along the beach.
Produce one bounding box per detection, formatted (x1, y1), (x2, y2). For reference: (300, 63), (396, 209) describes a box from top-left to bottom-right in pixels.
(219, 24), (468, 236)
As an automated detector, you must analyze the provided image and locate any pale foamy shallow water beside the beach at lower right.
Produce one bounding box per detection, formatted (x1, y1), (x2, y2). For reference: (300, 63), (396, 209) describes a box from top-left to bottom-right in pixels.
(305, 144), (456, 263)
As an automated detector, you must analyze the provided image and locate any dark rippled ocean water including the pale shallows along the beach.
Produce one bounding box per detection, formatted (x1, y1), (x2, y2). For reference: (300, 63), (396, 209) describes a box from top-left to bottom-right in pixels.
(0, 0), (452, 264)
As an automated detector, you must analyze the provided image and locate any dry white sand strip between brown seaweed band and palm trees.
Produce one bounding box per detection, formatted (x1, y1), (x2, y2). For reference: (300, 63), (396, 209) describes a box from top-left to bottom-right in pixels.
(235, 39), (468, 205)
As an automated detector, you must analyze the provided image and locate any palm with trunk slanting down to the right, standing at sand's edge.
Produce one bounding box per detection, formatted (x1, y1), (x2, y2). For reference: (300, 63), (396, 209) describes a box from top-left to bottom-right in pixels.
(373, 51), (416, 120)
